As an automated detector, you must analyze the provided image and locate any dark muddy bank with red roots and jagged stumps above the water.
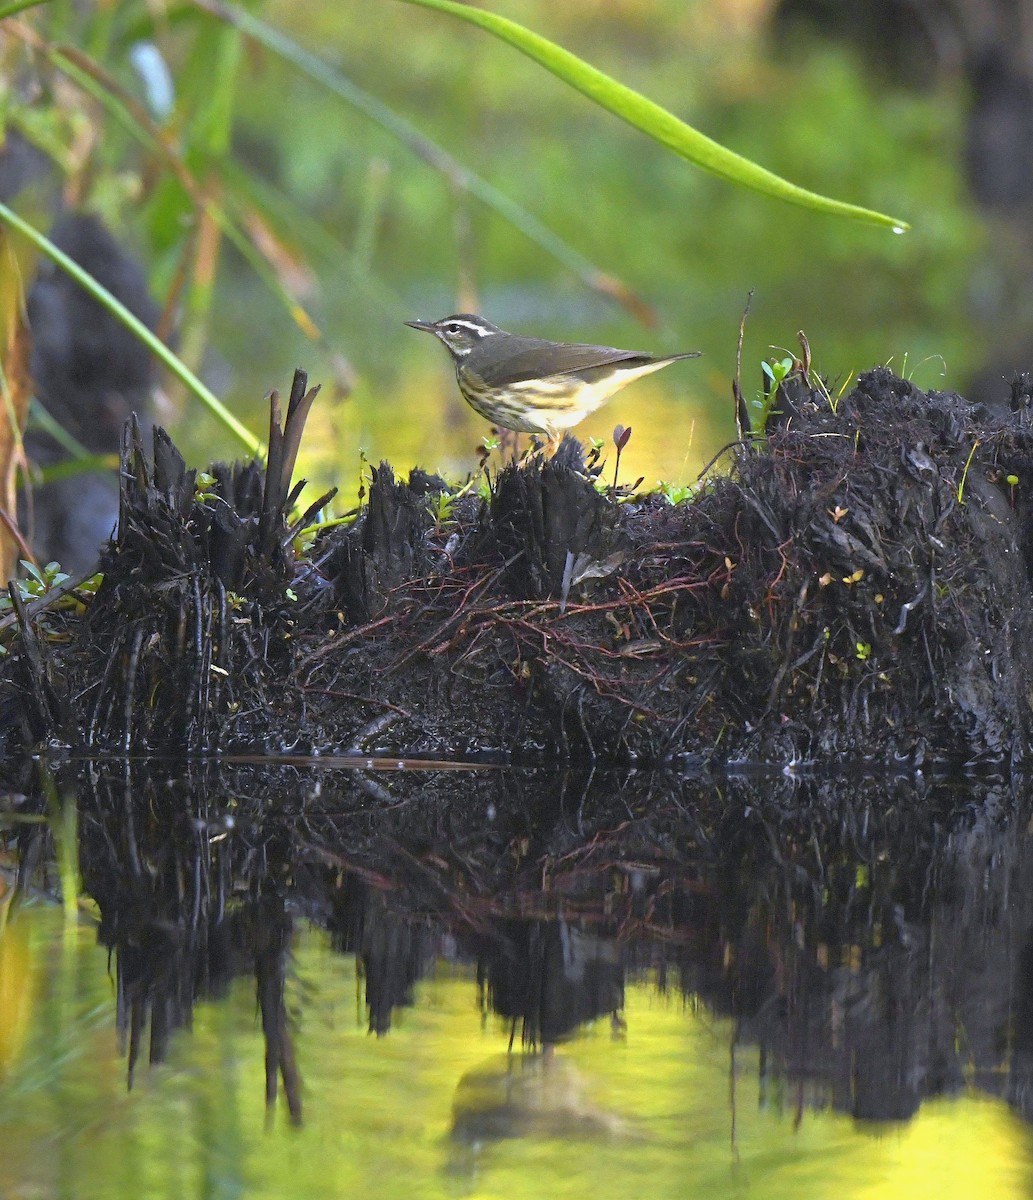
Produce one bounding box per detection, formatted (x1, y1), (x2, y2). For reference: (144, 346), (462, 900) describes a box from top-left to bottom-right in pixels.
(6, 368), (1033, 762)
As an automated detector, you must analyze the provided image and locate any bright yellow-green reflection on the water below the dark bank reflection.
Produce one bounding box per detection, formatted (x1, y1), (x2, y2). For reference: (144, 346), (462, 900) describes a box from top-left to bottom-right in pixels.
(0, 908), (1033, 1200)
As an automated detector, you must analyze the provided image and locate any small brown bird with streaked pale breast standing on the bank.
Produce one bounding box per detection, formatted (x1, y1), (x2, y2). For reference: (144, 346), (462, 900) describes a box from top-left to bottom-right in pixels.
(406, 313), (699, 438)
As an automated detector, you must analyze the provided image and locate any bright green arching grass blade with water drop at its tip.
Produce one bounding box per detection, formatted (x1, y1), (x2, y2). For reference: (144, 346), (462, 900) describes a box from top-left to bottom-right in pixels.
(404, 0), (911, 233)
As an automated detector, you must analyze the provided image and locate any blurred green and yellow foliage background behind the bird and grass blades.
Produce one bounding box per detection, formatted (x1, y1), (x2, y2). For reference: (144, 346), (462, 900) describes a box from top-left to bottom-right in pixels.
(2, 0), (986, 496)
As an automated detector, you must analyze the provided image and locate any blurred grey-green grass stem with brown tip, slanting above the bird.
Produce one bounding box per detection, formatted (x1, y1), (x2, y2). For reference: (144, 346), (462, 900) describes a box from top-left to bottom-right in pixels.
(192, 0), (656, 325)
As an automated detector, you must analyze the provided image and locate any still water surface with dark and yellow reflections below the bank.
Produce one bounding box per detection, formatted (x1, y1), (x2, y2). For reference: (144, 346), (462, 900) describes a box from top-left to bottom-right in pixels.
(0, 762), (1033, 1200)
